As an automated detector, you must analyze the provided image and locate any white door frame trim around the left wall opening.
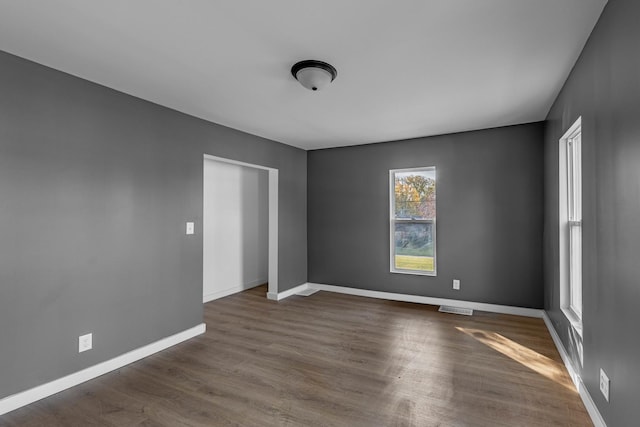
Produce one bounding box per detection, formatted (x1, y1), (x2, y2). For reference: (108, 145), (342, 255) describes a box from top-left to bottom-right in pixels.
(202, 154), (278, 295)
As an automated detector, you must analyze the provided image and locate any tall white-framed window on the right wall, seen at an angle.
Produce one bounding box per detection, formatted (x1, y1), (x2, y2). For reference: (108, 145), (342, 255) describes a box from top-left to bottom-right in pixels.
(559, 118), (582, 334)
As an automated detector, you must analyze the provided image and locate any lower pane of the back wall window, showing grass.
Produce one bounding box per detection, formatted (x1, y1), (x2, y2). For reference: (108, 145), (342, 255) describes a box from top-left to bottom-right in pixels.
(394, 221), (435, 272)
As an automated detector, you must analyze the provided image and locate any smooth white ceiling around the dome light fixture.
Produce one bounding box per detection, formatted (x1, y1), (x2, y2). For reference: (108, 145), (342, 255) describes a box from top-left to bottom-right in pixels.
(0, 0), (606, 149)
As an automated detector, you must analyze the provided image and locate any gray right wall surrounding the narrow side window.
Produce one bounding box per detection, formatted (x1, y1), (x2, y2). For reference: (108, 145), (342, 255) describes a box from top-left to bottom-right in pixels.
(544, 0), (640, 426)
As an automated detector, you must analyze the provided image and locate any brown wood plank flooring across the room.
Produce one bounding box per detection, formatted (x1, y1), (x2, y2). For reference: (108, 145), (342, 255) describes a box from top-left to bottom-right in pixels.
(0, 287), (592, 427)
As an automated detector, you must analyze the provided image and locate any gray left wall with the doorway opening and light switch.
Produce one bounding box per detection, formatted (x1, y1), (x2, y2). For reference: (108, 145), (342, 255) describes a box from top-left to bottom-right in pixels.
(0, 53), (307, 398)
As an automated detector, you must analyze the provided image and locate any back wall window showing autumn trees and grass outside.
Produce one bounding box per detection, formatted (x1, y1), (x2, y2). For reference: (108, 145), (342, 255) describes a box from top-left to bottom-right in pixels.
(389, 167), (436, 276)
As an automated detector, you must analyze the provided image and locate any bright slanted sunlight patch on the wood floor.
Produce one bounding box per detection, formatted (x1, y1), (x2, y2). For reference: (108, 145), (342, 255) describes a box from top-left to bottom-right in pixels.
(456, 326), (577, 393)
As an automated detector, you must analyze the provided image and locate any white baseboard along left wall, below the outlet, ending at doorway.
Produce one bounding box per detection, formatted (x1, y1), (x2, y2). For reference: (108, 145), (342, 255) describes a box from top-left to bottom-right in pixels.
(0, 323), (206, 415)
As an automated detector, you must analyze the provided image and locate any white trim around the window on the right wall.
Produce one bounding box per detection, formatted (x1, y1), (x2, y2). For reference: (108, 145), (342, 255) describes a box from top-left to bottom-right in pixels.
(558, 117), (583, 337)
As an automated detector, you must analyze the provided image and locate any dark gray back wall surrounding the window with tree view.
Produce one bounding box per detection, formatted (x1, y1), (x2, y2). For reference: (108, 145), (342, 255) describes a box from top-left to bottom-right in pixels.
(307, 123), (543, 308)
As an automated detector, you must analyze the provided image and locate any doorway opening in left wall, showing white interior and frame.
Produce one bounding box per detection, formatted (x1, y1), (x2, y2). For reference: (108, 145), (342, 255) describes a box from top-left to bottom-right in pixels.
(202, 154), (278, 302)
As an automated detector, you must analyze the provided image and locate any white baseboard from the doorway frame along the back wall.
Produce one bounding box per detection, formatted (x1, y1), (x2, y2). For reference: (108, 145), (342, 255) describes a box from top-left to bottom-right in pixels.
(278, 283), (543, 318)
